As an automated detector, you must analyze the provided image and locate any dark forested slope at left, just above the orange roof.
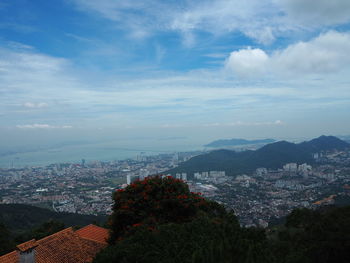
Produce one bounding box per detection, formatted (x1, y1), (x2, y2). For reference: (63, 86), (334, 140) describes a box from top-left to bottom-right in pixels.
(0, 204), (106, 234)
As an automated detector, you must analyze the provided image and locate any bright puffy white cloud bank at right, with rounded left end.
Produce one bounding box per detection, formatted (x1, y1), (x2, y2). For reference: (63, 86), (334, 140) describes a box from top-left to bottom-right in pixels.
(226, 31), (350, 77)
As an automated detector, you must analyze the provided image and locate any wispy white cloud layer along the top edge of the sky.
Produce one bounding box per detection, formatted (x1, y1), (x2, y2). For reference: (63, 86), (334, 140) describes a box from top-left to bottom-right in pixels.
(70, 0), (350, 47)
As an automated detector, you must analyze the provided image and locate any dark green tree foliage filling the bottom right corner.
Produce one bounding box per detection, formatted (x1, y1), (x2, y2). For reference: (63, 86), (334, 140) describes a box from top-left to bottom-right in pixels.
(271, 206), (350, 263)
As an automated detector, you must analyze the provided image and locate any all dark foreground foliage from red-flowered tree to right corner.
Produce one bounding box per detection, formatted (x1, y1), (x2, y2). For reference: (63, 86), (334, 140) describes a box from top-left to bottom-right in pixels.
(94, 177), (350, 263)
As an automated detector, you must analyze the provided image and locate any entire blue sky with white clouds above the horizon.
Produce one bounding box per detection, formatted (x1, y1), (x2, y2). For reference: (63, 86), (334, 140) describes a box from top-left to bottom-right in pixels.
(0, 0), (350, 155)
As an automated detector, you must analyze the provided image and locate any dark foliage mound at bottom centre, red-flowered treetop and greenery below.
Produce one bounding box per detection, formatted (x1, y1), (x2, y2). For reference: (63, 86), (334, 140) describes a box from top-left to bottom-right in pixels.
(95, 177), (271, 263)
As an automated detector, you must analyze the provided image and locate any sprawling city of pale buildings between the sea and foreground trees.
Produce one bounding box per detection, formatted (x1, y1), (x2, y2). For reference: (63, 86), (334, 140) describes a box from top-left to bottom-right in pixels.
(0, 145), (350, 227)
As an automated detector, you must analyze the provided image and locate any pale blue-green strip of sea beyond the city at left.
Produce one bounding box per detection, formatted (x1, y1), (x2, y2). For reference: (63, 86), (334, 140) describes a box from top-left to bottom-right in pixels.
(0, 141), (203, 168)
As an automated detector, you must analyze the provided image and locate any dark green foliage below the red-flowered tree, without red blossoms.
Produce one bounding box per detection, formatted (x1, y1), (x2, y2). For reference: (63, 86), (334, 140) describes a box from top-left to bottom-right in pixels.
(95, 217), (271, 263)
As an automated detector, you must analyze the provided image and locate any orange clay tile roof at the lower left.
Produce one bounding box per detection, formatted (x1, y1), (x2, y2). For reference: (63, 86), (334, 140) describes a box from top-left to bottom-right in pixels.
(0, 226), (108, 263)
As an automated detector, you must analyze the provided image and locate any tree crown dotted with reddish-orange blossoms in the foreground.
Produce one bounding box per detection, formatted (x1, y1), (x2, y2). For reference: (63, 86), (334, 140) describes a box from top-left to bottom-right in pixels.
(109, 176), (226, 243)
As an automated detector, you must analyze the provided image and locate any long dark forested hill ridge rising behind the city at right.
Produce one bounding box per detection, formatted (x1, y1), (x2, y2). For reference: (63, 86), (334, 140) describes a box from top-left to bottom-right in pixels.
(168, 135), (350, 175)
